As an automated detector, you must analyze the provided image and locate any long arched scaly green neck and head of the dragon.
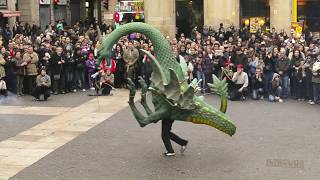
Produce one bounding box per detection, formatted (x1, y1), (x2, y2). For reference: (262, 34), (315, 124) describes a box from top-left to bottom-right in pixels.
(98, 23), (183, 80)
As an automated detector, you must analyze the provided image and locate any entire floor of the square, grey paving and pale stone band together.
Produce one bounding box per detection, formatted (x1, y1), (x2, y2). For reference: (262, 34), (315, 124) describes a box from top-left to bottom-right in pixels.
(0, 91), (320, 180)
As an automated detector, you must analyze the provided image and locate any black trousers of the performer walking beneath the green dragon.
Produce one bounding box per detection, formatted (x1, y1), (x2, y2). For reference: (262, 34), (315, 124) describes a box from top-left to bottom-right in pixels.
(161, 119), (188, 153)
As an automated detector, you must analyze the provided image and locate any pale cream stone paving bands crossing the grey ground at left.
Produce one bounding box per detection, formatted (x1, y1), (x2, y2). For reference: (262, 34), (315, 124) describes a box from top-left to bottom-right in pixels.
(0, 90), (128, 179)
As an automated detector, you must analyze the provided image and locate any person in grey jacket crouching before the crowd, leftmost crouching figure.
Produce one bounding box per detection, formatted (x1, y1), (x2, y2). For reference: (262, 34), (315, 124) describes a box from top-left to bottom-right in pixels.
(32, 69), (51, 101)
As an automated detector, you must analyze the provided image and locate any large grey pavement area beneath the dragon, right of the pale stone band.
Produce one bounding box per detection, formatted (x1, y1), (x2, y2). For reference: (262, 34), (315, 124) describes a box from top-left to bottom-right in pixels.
(8, 96), (320, 180)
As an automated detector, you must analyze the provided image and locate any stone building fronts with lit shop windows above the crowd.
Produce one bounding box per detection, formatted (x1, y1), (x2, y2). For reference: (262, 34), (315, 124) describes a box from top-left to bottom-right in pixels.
(0, 0), (320, 36)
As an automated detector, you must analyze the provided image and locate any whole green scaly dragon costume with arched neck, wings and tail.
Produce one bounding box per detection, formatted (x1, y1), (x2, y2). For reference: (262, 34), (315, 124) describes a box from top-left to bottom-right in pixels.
(98, 23), (236, 136)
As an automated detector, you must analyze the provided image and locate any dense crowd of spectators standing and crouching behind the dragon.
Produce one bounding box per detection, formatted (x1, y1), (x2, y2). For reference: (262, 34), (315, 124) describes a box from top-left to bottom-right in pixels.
(0, 22), (320, 104)
